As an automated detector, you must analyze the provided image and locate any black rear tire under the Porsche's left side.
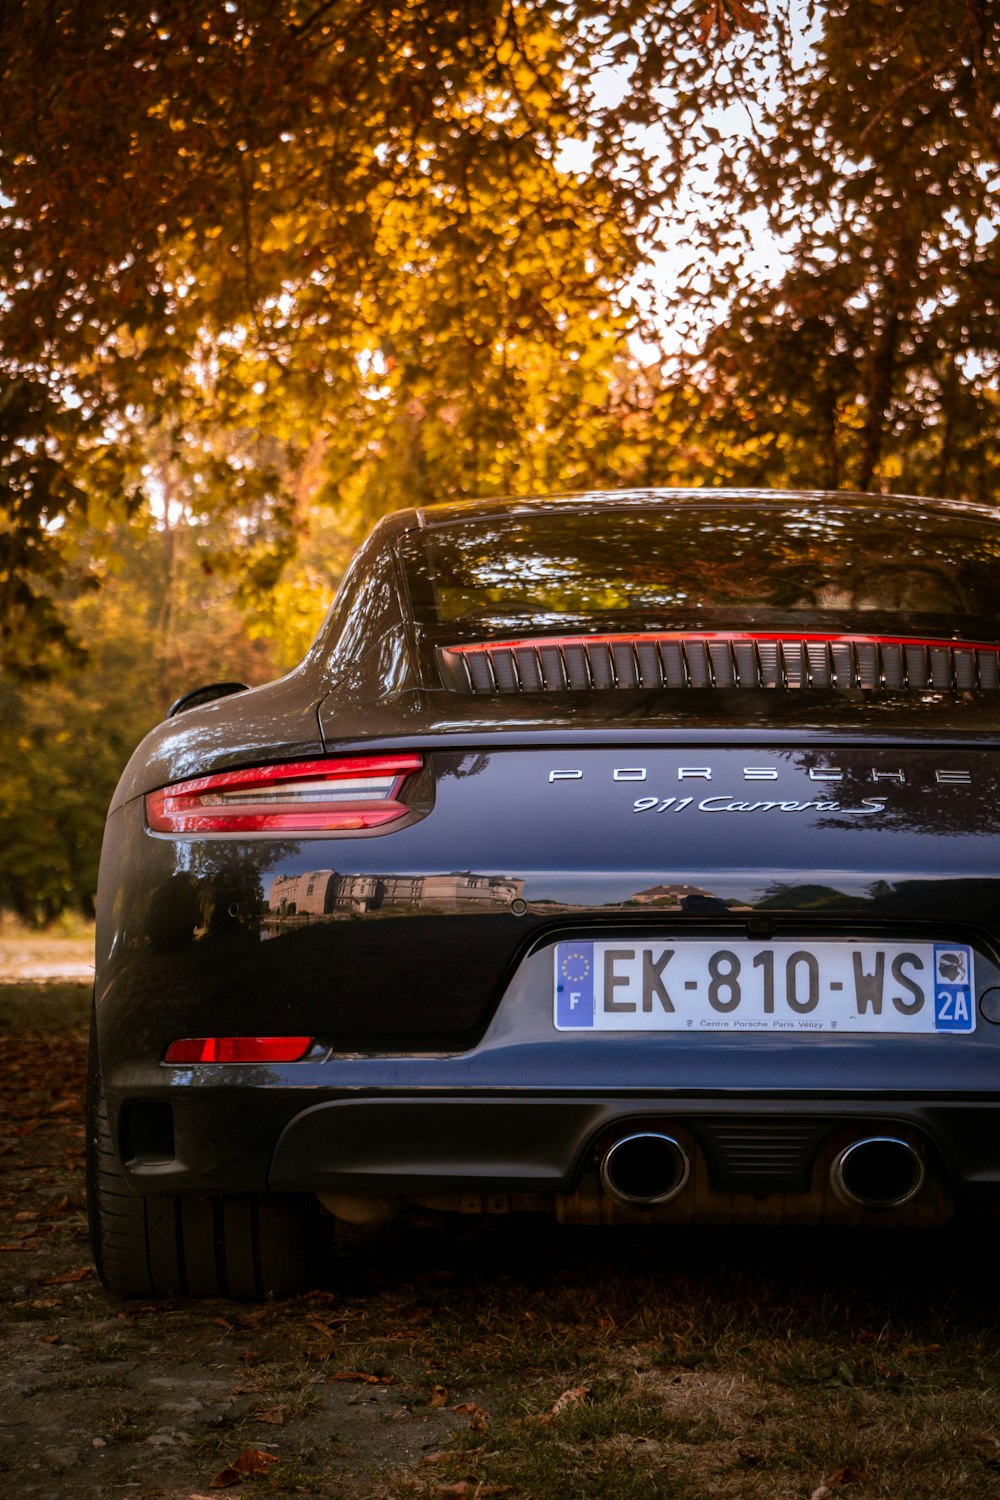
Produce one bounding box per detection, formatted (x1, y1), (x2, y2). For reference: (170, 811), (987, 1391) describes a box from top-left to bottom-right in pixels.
(87, 1023), (331, 1301)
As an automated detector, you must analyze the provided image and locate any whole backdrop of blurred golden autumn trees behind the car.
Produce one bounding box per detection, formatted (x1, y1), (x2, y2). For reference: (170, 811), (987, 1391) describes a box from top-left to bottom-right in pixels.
(0, 0), (1000, 917)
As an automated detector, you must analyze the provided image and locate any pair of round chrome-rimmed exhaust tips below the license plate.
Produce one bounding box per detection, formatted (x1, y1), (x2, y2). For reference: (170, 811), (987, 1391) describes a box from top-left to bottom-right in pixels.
(600, 1131), (925, 1211)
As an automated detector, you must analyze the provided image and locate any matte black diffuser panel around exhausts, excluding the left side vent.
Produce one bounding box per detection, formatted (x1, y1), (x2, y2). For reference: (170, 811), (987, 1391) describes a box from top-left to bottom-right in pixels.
(268, 1098), (1000, 1194)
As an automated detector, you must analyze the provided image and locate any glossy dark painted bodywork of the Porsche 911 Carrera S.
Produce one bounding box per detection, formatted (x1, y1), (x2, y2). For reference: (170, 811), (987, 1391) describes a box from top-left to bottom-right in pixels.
(96, 494), (1000, 1230)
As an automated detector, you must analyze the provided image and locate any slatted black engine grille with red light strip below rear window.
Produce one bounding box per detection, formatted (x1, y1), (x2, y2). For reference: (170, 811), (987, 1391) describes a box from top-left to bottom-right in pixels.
(438, 632), (1000, 693)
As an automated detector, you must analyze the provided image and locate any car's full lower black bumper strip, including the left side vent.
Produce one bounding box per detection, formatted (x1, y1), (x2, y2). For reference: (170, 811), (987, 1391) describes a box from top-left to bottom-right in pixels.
(118, 1088), (1000, 1206)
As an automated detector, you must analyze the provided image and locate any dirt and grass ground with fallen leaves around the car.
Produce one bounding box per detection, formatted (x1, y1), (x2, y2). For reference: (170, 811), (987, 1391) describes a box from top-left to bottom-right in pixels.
(0, 986), (1000, 1500)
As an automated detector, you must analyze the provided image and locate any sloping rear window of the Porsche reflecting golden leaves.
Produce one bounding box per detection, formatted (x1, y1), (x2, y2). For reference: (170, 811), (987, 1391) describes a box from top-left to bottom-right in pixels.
(403, 506), (1000, 629)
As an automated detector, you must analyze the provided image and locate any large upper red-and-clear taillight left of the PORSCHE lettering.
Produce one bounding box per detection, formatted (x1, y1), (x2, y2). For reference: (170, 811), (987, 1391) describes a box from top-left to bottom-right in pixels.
(145, 755), (423, 834)
